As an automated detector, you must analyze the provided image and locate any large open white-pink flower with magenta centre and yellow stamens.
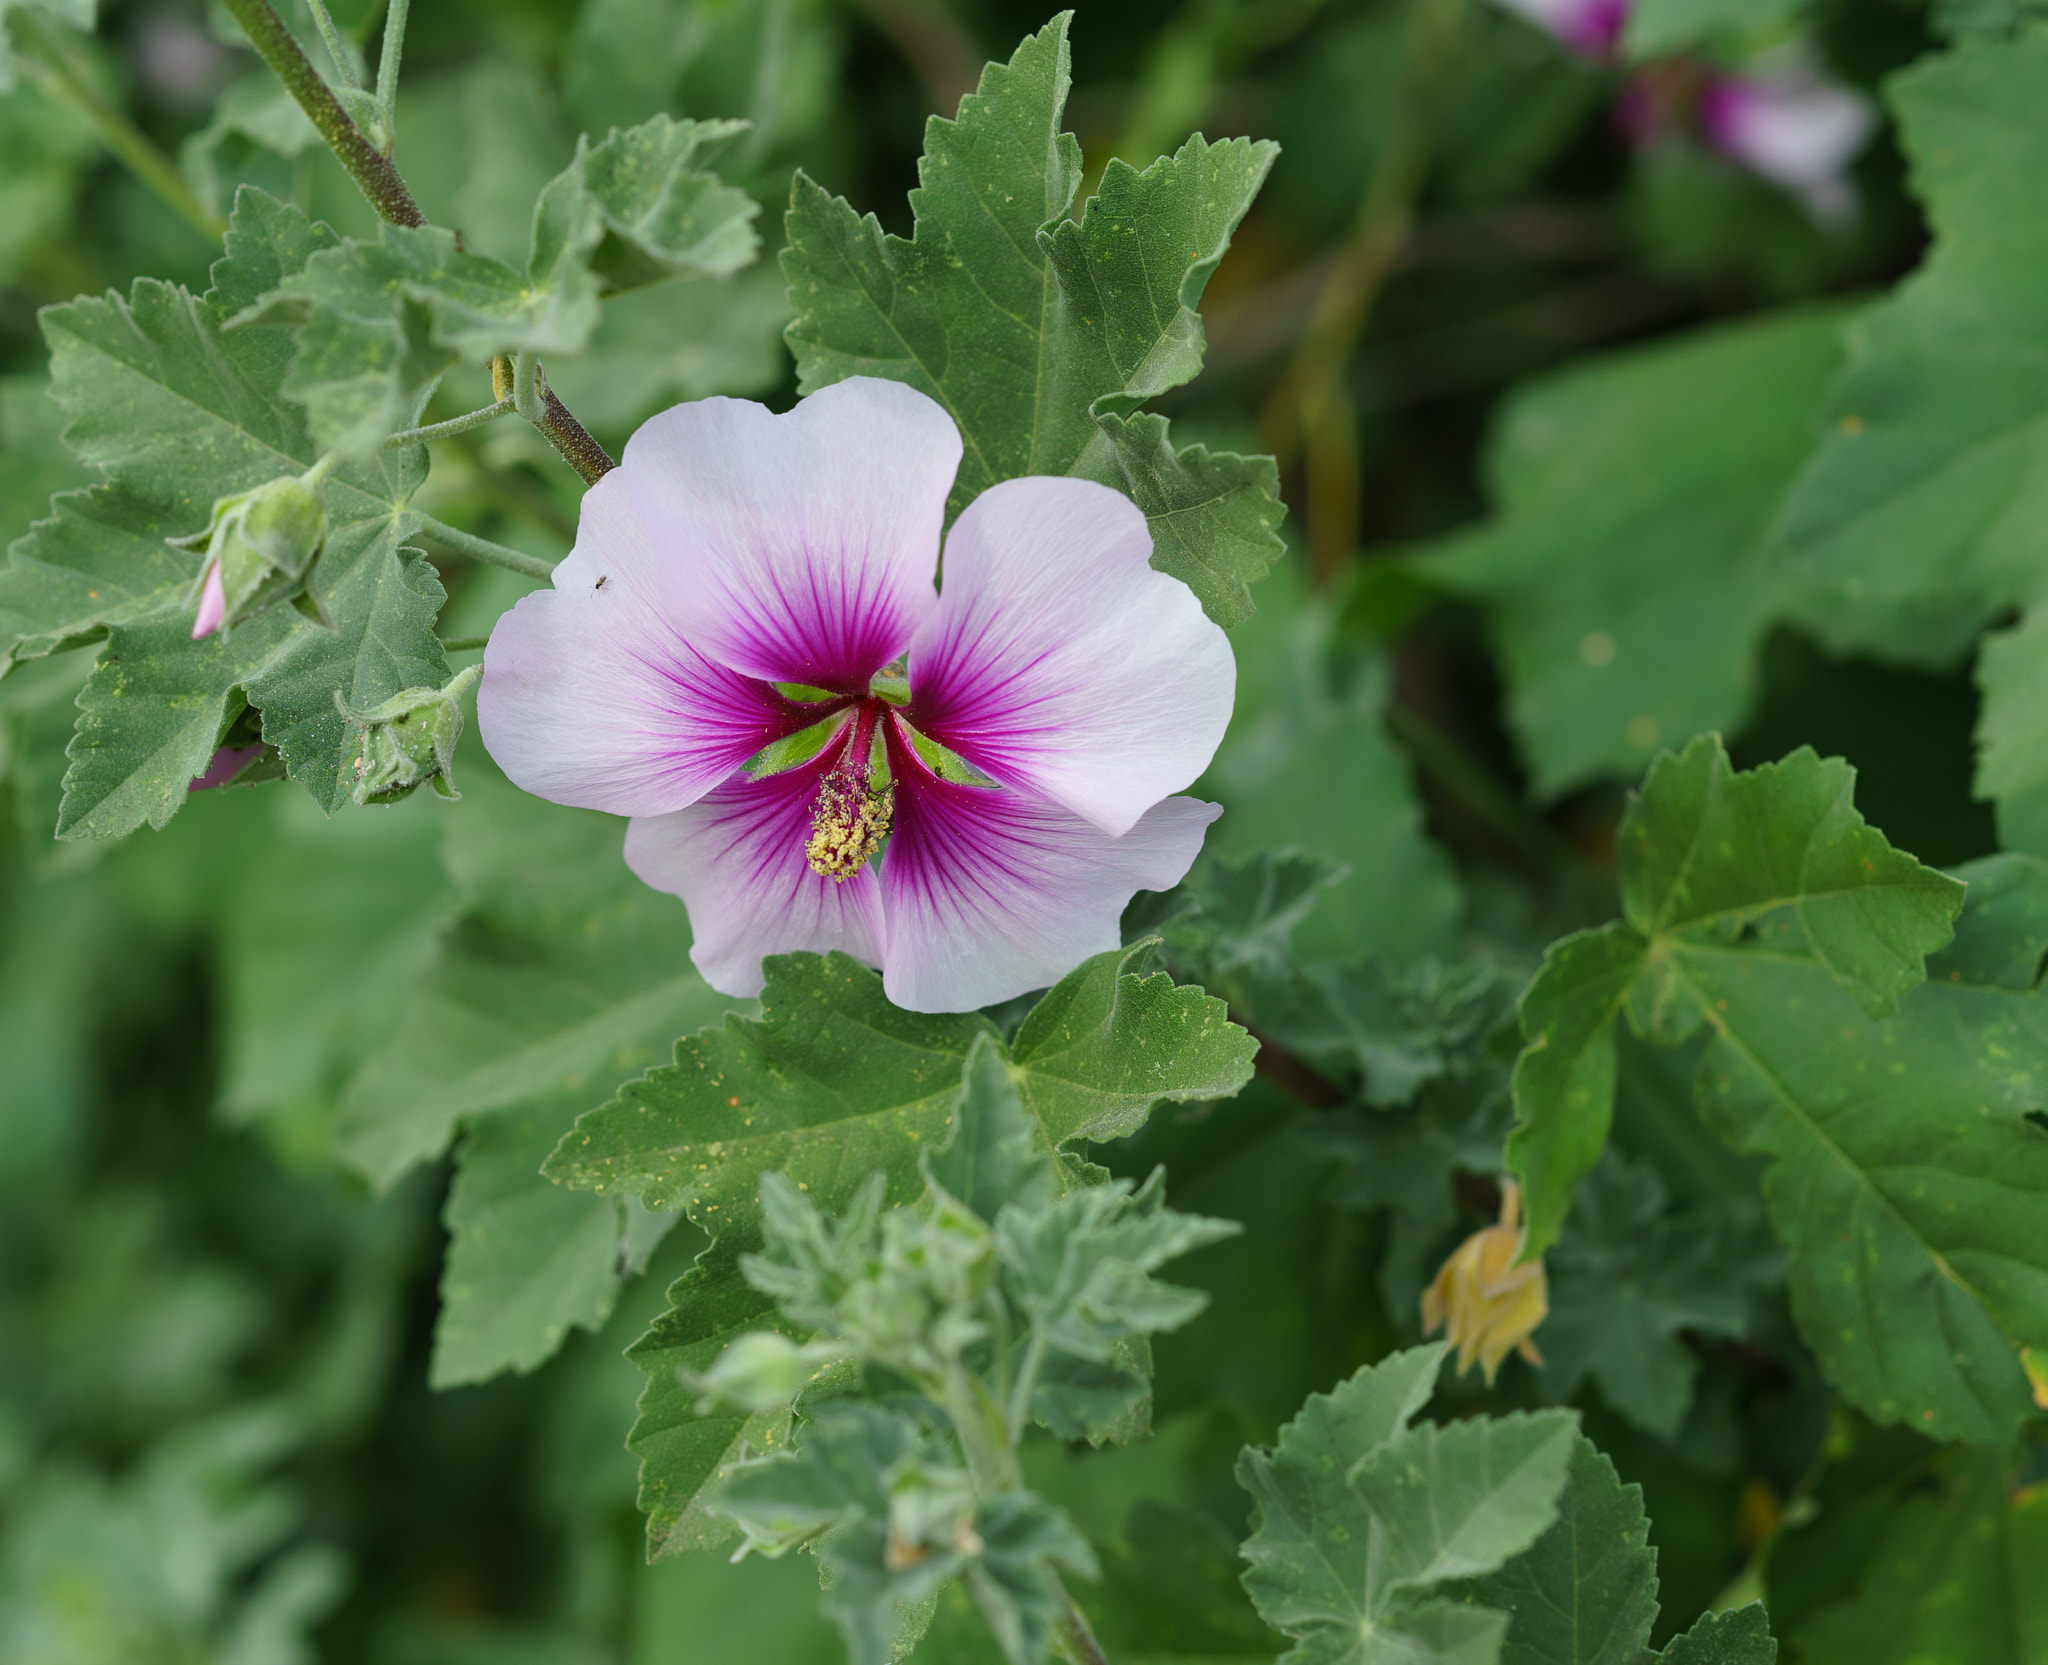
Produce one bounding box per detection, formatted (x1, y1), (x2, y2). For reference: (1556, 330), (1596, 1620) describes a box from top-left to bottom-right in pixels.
(477, 377), (1235, 1012)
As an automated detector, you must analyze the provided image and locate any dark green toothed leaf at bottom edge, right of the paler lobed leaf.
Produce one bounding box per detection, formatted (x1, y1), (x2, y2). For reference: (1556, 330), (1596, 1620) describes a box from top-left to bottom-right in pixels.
(1473, 1425), (1657, 1665)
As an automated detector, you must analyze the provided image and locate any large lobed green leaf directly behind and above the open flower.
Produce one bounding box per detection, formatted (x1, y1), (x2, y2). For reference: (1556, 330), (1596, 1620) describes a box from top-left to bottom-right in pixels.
(782, 14), (1280, 625)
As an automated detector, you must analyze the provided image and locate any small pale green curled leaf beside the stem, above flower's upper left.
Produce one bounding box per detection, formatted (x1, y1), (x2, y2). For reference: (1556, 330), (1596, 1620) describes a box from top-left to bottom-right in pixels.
(528, 115), (760, 295)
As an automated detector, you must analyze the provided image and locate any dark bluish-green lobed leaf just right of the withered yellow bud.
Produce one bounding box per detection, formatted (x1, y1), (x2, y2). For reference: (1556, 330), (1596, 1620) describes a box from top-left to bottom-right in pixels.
(1542, 1151), (1784, 1440)
